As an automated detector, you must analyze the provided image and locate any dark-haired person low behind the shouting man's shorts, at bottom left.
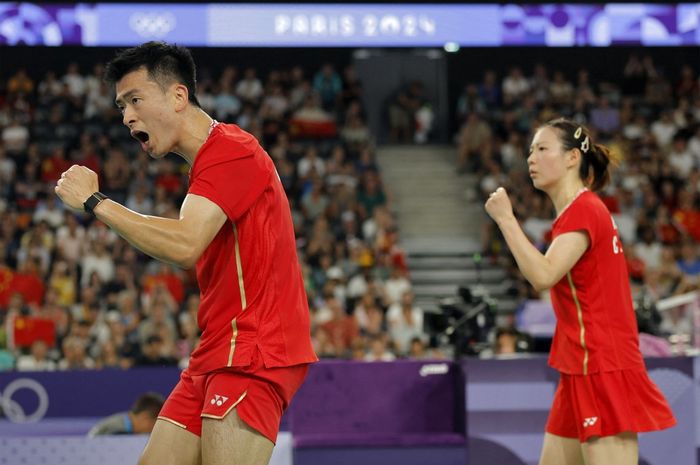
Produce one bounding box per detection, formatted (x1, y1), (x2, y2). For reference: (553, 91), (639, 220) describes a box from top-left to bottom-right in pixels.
(88, 392), (163, 437)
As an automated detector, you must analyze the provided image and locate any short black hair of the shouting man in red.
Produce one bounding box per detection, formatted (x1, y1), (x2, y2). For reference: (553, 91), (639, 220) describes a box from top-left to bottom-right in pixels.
(104, 42), (200, 107)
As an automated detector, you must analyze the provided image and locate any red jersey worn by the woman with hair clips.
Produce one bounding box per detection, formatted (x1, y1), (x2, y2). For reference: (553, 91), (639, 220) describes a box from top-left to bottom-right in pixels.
(549, 190), (644, 375)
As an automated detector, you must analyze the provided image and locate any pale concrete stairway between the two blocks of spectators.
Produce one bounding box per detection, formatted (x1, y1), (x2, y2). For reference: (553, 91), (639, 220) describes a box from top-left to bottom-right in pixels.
(378, 146), (516, 313)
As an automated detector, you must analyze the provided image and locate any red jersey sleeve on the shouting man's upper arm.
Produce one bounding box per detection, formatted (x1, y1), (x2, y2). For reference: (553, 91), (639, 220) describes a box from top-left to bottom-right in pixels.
(189, 152), (271, 221)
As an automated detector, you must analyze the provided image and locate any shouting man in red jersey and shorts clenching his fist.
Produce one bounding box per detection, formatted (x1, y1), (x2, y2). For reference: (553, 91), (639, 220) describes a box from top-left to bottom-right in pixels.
(56, 42), (317, 465)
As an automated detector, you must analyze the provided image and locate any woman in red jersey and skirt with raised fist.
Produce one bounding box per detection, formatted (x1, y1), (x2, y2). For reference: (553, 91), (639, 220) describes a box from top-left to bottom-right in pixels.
(486, 119), (676, 465)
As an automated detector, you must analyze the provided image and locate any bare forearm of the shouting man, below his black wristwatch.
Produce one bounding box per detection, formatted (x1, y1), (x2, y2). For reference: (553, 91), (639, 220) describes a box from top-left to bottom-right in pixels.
(94, 199), (197, 268)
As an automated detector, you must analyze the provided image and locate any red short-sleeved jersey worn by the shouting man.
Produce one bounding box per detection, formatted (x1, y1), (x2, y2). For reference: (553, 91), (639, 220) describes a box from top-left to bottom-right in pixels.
(189, 124), (317, 374)
